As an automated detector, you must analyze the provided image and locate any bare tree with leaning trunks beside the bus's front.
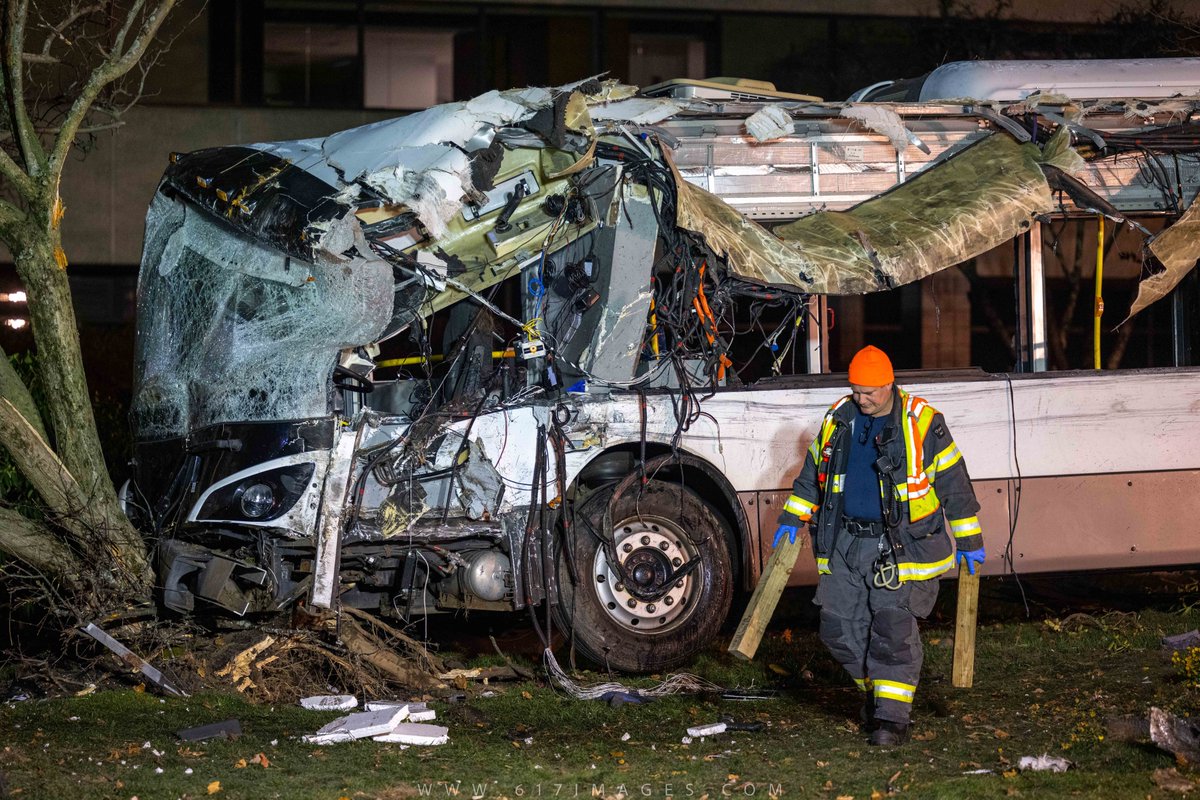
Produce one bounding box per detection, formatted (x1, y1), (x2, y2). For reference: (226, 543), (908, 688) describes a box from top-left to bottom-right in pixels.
(0, 0), (176, 606)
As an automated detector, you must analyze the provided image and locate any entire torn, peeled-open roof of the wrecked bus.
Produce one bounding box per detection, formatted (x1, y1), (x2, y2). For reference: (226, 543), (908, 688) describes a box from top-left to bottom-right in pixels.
(164, 74), (1200, 317)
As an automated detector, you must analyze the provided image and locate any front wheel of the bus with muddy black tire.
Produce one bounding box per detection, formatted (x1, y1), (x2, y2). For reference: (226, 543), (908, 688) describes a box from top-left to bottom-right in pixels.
(557, 481), (733, 672)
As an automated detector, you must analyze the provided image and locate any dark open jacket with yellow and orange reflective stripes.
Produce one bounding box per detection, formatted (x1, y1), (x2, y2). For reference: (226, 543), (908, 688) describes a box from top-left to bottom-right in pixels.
(784, 387), (983, 581)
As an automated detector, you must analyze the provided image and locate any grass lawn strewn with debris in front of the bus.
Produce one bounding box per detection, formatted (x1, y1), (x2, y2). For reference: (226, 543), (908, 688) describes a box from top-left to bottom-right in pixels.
(0, 582), (1200, 800)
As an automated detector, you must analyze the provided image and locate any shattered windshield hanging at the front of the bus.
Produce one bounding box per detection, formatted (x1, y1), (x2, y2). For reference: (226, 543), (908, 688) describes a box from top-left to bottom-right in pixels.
(133, 193), (392, 439)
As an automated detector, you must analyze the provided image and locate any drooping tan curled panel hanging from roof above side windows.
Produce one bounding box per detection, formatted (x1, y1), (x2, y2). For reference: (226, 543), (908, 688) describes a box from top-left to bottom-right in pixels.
(665, 133), (1055, 295)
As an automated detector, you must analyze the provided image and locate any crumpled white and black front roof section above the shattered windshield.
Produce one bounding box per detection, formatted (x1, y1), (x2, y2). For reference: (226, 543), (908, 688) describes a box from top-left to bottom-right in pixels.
(166, 80), (667, 260)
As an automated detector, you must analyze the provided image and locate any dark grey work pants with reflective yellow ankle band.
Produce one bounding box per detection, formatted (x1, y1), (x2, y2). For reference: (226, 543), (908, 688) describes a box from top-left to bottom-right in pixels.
(814, 530), (937, 723)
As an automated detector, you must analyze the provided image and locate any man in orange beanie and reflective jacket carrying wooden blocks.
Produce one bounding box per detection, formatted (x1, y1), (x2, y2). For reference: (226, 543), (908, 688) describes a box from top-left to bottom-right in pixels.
(774, 347), (984, 746)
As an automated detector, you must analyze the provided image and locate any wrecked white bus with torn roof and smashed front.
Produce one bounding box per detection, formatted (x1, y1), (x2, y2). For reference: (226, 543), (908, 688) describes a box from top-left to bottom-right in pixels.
(129, 59), (1200, 670)
